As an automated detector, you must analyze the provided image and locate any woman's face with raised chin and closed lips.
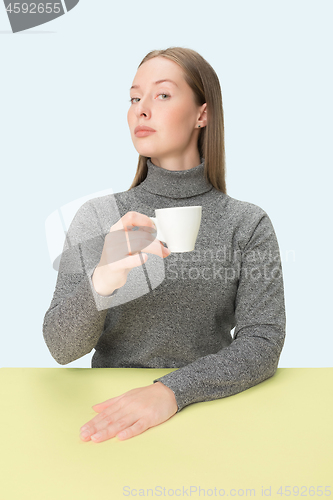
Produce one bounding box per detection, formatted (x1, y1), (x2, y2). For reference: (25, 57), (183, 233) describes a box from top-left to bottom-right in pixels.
(127, 57), (206, 166)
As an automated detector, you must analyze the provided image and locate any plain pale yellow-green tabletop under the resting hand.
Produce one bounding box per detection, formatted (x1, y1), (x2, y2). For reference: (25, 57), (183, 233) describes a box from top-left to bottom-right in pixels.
(0, 368), (333, 500)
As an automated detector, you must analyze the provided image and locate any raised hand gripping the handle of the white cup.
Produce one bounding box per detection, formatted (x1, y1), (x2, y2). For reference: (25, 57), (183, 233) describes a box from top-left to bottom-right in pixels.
(92, 212), (171, 295)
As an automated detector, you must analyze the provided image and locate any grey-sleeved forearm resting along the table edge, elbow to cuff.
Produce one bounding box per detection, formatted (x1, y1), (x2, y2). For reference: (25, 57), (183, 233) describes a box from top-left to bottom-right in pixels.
(154, 325), (285, 411)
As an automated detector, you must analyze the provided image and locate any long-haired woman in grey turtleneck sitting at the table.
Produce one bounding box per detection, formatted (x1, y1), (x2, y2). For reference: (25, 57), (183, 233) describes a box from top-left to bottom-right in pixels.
(43, 47), (285, 442)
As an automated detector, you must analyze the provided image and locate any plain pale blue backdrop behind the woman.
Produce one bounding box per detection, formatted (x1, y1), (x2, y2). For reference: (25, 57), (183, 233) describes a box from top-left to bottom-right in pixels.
(0, 0), (333, 367)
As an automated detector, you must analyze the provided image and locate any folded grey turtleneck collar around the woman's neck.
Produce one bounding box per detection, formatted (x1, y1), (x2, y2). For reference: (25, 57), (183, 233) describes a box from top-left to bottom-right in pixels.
(140, 158), (213, 198)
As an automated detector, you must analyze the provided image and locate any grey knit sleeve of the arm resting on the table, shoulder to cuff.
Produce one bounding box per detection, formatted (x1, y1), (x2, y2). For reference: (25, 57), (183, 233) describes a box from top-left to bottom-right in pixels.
(154, 210), (286, 413)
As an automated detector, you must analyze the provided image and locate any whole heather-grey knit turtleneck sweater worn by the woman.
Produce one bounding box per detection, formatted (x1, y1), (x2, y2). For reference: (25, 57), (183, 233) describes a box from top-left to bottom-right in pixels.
(43, 159), (286, 411)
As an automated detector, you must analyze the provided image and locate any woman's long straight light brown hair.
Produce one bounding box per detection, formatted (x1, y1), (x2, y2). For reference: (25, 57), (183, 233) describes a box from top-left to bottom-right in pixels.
(128, 47), (227, 194)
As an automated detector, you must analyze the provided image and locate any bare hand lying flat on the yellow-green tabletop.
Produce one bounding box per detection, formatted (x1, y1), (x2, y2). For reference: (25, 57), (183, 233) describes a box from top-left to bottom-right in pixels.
(80, 382), (178, 443)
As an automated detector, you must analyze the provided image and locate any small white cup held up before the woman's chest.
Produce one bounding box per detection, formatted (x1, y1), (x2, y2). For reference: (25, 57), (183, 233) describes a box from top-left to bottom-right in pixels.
(149, 206), (202, 252)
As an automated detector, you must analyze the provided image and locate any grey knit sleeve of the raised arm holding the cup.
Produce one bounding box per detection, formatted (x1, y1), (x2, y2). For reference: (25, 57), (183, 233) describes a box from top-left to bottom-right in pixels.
(43, 200), (118, 365)
